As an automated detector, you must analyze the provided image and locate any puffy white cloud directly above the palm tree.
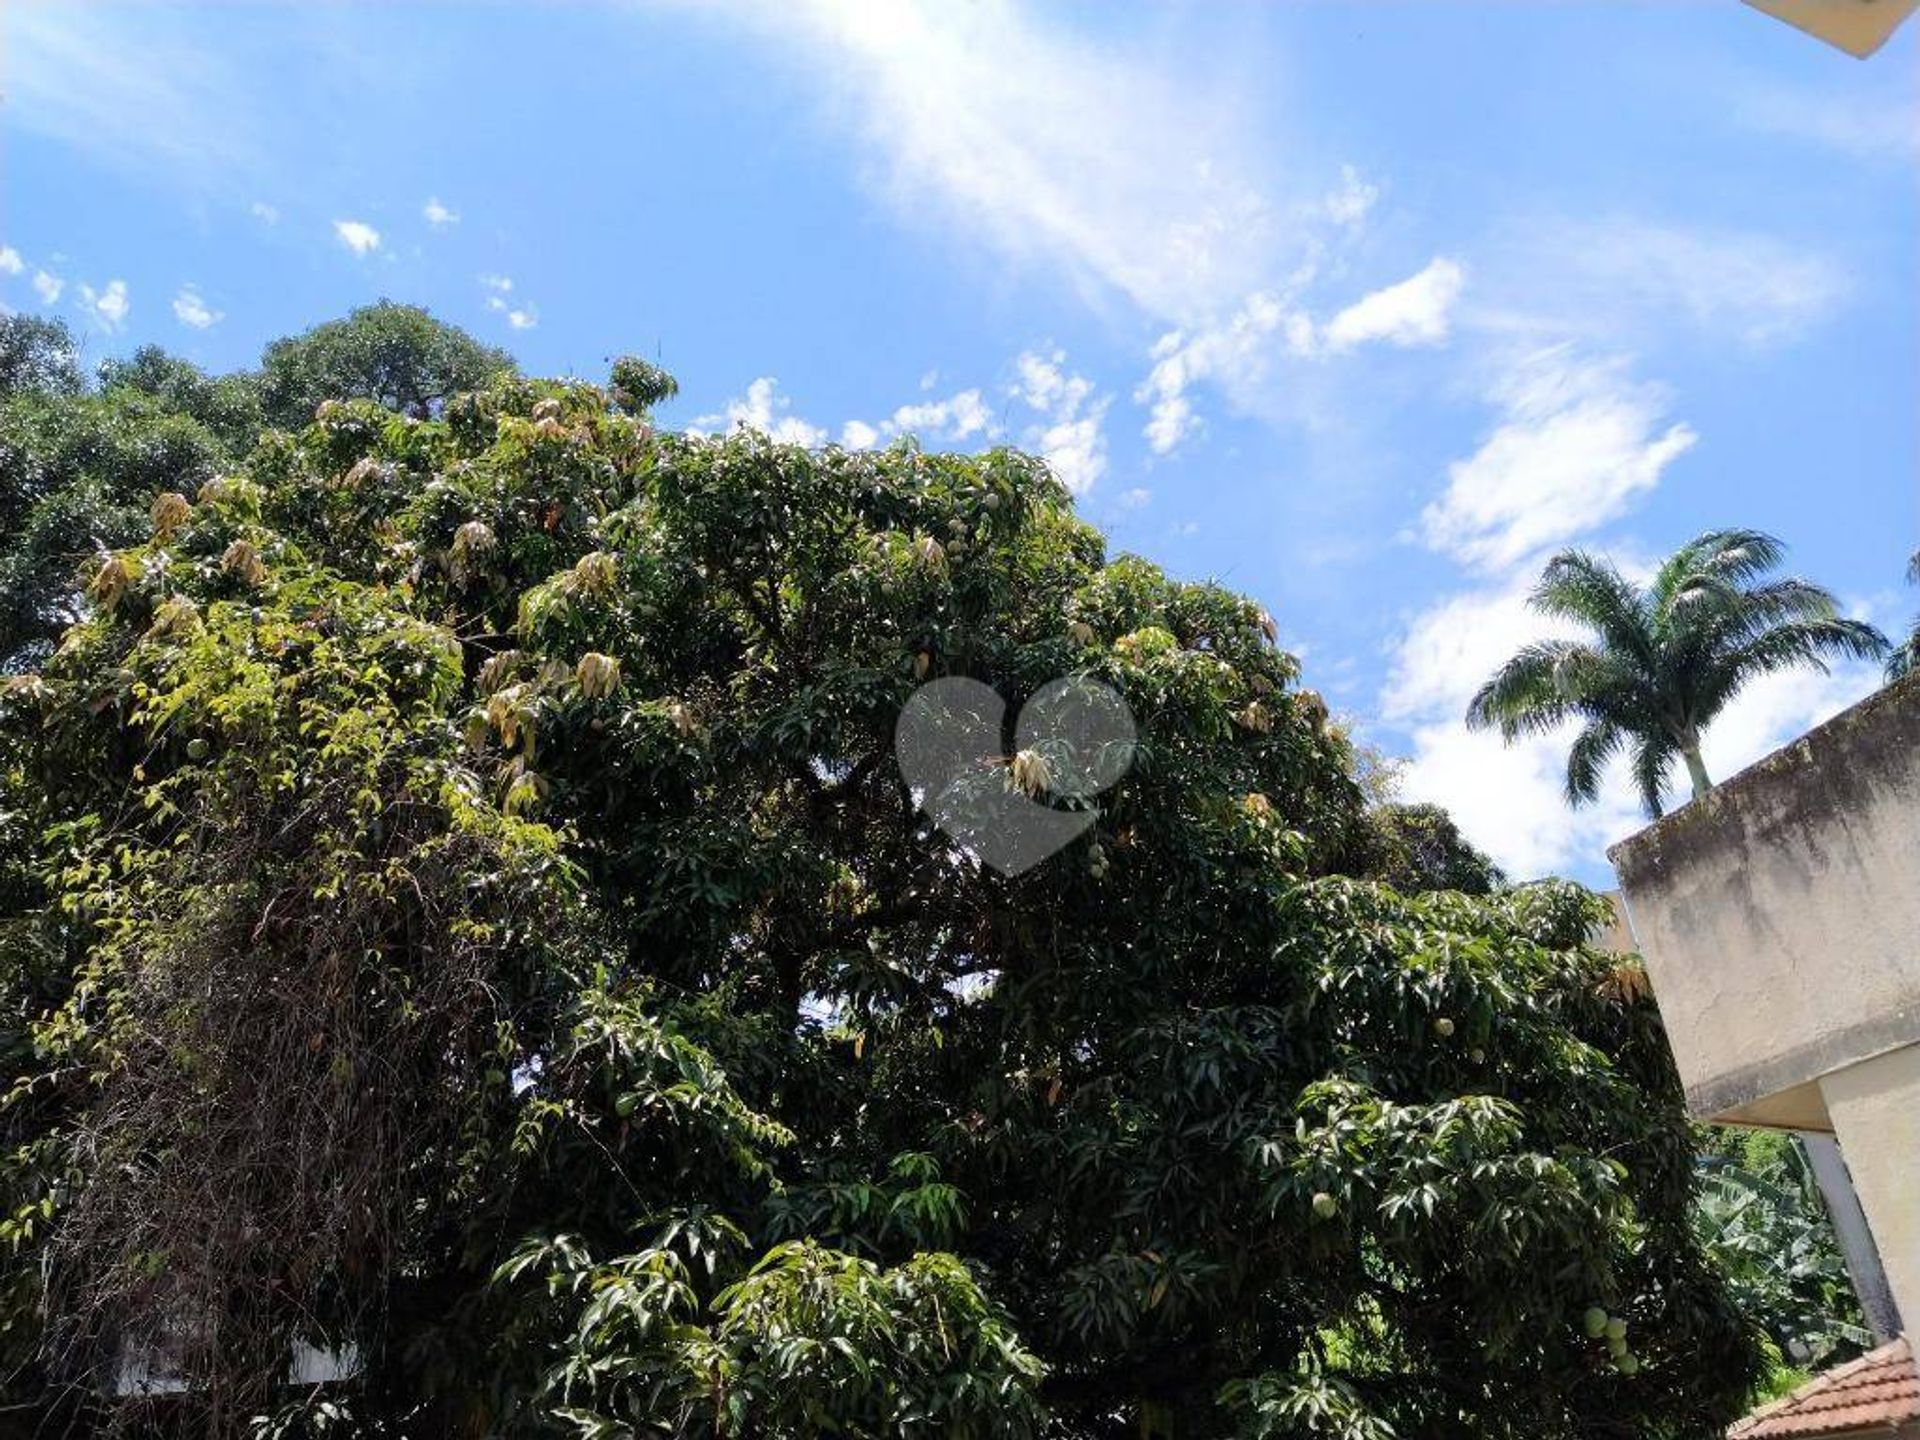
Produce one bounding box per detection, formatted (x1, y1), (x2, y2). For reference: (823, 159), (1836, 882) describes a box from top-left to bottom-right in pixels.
(1421, 346), (1697, 570)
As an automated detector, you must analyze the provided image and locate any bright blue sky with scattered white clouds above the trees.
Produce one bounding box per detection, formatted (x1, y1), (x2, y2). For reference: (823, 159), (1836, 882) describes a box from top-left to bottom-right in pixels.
(0, 0), (1920, 879)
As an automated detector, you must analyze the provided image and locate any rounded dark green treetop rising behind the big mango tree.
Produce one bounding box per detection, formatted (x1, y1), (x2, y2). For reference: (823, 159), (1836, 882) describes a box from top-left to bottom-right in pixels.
(259, 300), (515, 428)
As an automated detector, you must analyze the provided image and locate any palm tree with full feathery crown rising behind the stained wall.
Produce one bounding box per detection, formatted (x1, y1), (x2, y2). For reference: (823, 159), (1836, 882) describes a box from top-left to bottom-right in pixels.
(1467, 530), (1887, 818)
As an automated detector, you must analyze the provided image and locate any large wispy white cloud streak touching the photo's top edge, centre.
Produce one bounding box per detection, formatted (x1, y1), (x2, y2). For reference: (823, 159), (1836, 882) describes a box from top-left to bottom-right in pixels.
(702, 0), (1277, 323)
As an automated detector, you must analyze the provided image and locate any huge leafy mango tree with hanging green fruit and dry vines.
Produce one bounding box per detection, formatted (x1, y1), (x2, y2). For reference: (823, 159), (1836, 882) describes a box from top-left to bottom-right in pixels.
(0, 326), (1761, 1440)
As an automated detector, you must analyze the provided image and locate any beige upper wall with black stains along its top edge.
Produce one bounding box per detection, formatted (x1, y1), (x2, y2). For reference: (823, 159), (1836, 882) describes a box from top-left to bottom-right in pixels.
(1611, 676), (1920, 1136)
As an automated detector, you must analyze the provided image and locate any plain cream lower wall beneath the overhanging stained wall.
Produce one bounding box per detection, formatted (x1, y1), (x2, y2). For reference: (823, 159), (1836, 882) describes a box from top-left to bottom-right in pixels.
(1820, 1044), (1920, 1332)
